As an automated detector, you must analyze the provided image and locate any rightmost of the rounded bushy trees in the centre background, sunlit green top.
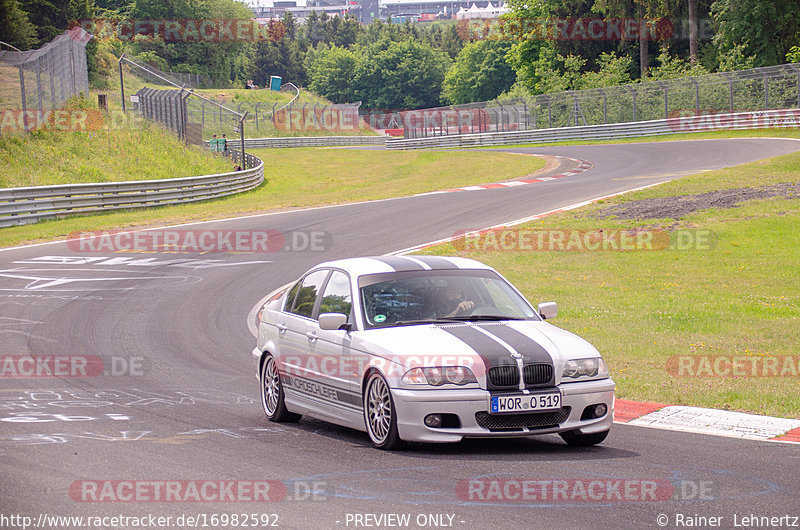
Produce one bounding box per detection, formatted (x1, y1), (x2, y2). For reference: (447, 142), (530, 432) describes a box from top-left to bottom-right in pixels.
(442, 40), (516, 104)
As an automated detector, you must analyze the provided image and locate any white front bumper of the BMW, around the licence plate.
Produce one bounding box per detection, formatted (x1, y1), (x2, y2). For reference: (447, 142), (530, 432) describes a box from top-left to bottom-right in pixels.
(392, 379), (615, 443)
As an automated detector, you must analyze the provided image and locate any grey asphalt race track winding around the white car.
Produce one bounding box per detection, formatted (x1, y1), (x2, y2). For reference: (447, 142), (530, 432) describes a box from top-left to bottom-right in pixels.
(0, 138), (800, 529)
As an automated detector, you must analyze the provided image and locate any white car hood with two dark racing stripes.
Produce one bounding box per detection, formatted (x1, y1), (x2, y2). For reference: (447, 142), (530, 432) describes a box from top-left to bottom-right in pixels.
(352, 320), (600, 386)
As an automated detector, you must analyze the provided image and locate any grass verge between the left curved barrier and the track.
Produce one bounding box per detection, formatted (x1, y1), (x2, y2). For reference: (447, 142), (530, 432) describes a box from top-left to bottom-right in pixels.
(0, 148), (544, 246)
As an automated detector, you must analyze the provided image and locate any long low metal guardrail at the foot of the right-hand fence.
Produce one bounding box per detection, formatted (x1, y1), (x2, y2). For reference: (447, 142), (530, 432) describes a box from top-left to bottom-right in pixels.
(386, 109), (800, 149)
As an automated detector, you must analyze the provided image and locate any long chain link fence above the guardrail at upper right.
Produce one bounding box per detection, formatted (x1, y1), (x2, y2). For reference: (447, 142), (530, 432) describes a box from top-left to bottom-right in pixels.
(400, 63), (800, 138)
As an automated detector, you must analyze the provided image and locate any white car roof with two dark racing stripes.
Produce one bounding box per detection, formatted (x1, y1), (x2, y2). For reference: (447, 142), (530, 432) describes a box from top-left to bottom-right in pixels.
(314, 255), (493, 277)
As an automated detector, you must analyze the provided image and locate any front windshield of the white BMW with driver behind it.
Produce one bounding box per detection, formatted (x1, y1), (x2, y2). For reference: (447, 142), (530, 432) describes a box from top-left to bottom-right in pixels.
(359, 270), (538, 328)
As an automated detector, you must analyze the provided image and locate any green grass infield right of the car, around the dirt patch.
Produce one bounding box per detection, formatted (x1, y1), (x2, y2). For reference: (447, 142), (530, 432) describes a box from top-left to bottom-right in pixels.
(426, 148), (800, 418)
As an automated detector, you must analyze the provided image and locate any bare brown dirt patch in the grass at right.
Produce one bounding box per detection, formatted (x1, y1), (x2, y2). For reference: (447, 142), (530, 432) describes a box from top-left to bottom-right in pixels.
(594, 182), (800, 220)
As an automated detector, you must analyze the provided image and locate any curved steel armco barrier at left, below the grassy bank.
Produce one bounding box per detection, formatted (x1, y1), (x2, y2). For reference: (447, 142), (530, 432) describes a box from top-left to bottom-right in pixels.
(0, 154), (264, 227)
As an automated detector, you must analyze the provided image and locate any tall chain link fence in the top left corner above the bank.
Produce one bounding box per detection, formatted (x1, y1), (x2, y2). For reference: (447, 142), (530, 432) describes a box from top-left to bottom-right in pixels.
(0, 27), (92, 135)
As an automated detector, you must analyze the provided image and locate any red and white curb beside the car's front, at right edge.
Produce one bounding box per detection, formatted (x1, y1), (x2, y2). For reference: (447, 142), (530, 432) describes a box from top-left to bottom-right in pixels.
(614, 399), (800, 444)
